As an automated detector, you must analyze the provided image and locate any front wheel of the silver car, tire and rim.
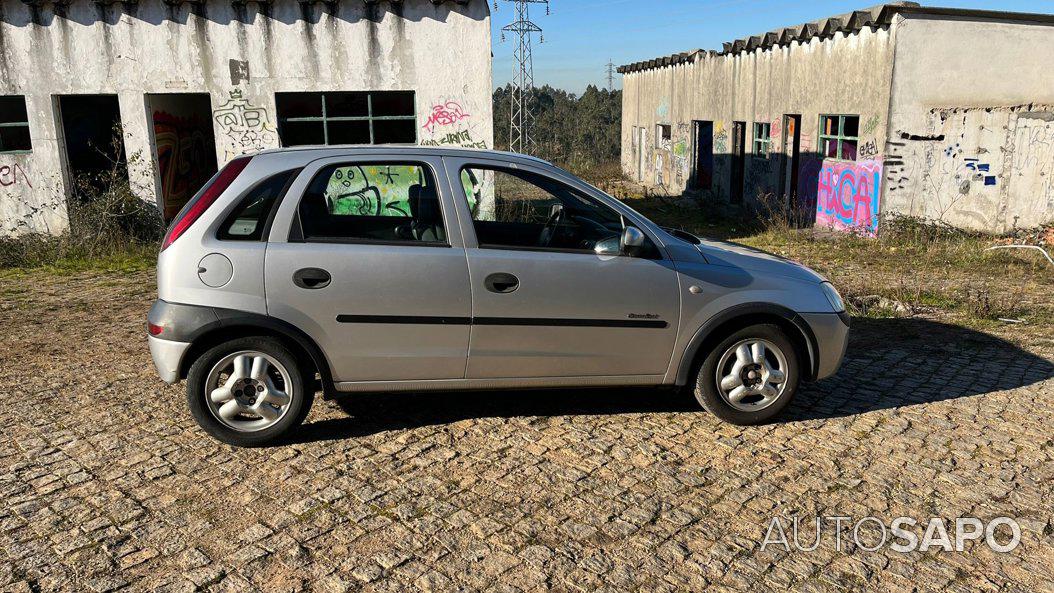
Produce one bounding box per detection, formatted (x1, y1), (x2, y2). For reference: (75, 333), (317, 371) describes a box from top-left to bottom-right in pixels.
(694, 323), (801, 426)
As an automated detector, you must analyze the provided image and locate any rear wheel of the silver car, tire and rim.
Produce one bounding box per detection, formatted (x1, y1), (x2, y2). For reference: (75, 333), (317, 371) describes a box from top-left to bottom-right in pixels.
(187, 337), (314, 447)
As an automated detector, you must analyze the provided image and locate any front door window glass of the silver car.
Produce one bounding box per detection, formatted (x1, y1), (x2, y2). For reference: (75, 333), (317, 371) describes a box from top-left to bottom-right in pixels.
(461, 165), (622, 252)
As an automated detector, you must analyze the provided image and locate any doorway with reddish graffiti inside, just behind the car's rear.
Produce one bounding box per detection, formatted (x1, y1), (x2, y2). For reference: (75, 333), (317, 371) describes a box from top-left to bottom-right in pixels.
(147, 93), (216, 220)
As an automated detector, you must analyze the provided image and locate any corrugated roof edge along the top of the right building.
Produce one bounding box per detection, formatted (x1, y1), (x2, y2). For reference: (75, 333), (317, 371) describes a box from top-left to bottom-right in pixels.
(619, 2), (1054, 74)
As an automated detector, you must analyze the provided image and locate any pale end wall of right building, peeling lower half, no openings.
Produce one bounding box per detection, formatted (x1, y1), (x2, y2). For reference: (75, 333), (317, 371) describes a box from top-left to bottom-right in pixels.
(883, 16), (1054, 232)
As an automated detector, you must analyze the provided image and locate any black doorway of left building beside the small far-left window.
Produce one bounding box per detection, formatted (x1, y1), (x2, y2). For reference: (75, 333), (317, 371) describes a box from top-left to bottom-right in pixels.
(59, 95), (128, 194)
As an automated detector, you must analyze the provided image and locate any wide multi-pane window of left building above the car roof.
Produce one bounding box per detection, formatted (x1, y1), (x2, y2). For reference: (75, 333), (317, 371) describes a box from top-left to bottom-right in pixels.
(274, 91), (417, 146)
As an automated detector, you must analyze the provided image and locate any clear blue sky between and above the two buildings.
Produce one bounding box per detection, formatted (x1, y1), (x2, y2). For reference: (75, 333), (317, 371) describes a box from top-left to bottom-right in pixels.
(488, 0), (1054, 93)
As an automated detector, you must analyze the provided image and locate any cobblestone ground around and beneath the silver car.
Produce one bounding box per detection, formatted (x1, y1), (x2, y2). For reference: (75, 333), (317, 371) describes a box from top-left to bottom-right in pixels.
(0, 274), (1054, 591)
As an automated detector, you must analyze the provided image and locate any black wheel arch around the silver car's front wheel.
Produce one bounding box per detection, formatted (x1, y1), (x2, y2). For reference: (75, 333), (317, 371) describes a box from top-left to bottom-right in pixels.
(675, 302), (819, 387)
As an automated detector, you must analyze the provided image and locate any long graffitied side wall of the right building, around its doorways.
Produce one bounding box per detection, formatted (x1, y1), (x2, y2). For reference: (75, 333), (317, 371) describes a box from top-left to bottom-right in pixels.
(622, 27), (894, 232)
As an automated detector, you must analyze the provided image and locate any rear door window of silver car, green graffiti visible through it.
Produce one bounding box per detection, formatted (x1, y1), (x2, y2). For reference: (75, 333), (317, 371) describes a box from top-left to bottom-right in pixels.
(297, 162), (447, 244)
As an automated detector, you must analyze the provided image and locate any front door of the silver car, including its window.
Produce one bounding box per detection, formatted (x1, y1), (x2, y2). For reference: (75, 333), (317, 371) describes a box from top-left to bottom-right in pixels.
(445, 157), (680, 379)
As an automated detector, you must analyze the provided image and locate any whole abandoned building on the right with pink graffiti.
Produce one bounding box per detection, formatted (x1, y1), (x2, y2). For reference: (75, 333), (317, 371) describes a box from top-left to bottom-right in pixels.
(619, 2), (1054, 234)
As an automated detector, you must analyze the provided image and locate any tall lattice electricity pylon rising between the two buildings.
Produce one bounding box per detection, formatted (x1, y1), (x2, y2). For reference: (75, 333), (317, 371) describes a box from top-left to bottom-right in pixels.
(494, 0), (549, 154)
